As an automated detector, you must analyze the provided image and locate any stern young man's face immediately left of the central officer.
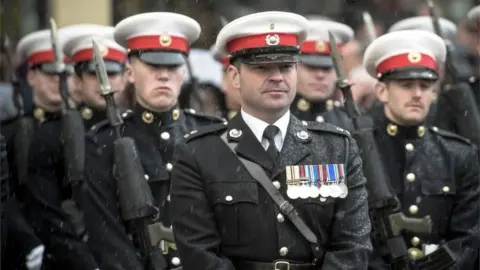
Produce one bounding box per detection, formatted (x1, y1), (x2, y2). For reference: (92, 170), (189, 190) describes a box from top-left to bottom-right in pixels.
(127, 58), (185, 112)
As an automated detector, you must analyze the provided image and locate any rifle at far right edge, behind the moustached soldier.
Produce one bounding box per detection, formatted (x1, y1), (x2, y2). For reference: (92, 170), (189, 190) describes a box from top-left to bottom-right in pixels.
(427, 0), (480, 145)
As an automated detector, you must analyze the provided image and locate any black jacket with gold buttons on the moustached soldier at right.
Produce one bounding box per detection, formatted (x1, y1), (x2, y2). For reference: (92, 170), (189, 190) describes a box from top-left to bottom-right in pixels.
(366, 106), (480, 270)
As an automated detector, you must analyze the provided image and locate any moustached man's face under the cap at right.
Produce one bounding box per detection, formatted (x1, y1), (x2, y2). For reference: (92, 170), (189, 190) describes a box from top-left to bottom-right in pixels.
(375, 79), (435, 126)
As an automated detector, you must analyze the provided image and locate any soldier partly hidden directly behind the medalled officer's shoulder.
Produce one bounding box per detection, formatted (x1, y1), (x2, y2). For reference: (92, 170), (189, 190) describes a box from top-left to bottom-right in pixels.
(291, 19), (354, 124)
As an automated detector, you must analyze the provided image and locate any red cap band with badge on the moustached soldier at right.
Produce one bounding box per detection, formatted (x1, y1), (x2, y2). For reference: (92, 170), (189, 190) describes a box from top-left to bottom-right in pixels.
(377, 52), (437, 74)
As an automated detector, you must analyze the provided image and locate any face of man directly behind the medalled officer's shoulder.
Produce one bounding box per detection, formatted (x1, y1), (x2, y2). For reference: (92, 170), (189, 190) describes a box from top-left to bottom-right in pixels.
(297, 64), (337, 101)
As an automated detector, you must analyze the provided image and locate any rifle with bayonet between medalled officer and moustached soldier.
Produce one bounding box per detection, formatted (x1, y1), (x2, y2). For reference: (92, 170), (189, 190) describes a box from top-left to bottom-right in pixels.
(329, 32), (455, 270)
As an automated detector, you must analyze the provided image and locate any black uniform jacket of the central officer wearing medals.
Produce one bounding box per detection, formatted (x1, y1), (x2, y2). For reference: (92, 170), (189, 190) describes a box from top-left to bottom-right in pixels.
(171, 114), (371, 270)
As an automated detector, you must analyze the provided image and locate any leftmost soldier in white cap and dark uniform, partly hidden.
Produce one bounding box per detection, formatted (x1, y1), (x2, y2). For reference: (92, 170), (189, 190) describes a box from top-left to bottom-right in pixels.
(15, 26), (97, 270)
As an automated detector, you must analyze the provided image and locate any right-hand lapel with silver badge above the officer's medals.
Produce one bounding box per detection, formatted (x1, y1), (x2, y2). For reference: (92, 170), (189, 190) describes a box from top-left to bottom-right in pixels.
(272, 115), (312, 179)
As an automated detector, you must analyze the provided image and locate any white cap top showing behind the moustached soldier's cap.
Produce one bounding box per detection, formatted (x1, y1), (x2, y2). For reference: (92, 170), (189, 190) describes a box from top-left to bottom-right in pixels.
(388, 16), (457, 40)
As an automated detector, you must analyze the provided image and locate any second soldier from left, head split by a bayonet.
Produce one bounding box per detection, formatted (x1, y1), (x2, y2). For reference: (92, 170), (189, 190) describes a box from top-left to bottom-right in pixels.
(63, 25), (127, 129)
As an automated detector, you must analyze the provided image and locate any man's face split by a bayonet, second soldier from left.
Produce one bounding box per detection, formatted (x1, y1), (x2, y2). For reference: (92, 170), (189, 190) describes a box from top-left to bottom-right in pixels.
(75, 72), (126, 109)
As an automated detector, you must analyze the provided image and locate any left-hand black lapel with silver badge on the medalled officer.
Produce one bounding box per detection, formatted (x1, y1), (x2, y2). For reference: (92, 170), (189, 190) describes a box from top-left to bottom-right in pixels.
(227, 113), (274, 172)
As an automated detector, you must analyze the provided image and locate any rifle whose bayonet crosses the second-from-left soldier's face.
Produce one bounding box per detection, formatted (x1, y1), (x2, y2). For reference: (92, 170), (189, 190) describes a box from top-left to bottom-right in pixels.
(92, 39), (174, 270)
